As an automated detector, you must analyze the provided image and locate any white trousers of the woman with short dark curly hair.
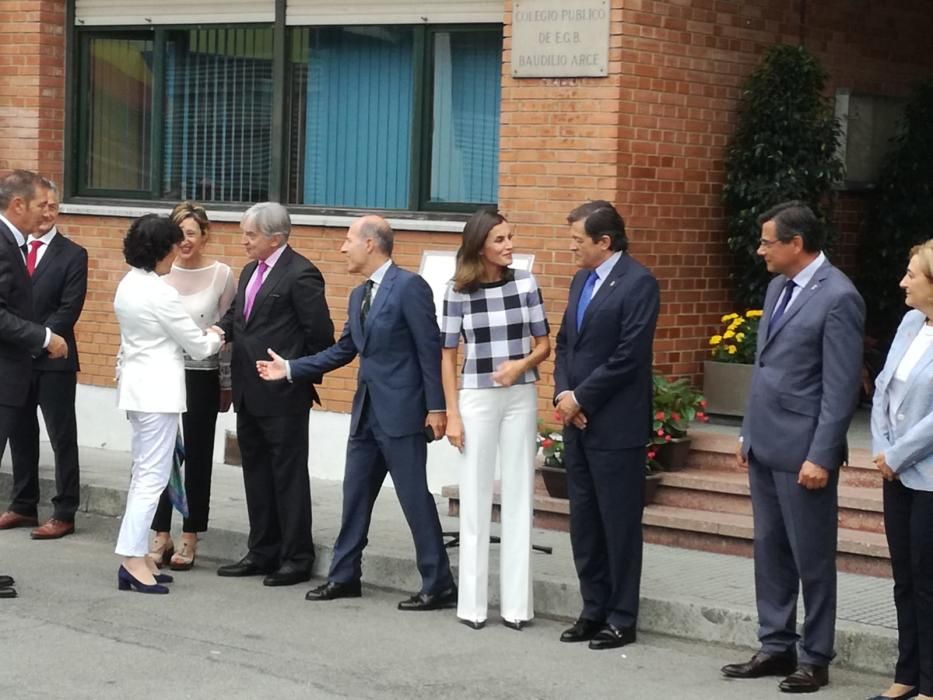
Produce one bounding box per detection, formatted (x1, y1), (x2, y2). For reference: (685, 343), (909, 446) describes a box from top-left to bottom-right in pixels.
(114, 411), (178, 557)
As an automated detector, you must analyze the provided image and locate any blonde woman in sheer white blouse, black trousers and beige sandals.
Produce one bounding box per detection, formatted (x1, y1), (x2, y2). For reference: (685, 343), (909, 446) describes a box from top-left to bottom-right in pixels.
(149, 202), (236, 571)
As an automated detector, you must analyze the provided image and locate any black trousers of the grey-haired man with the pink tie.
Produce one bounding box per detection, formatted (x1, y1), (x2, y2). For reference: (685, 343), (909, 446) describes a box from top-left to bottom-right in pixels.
(237, 405), (314, 568)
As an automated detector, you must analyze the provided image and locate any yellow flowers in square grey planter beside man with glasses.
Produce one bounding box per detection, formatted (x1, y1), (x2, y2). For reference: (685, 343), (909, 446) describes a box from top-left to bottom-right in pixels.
(703, 309), (762, 416)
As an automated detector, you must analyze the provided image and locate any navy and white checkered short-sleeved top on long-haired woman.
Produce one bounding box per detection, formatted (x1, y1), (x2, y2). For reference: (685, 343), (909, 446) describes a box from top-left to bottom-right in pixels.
(441, 270), (549, 389)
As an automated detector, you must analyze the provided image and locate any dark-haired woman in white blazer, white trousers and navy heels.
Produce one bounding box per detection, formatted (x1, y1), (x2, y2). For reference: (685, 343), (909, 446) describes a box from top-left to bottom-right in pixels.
(113, 214), (223, 593)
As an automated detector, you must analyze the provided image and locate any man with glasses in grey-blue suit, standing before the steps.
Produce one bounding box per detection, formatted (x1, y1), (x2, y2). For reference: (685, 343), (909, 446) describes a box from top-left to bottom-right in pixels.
(722, 202), (865, 693)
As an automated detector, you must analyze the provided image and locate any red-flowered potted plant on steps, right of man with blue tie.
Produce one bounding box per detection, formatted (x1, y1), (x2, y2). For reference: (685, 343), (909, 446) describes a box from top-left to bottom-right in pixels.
(648, 373), (708, 471)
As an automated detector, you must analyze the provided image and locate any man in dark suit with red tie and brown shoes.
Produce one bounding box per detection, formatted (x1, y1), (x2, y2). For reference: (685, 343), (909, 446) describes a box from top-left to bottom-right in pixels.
(10, 180), (87, 540)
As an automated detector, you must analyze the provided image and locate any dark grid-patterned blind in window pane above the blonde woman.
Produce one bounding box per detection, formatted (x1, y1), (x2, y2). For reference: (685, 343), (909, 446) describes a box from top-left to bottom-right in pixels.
(162, 29), (272, 202)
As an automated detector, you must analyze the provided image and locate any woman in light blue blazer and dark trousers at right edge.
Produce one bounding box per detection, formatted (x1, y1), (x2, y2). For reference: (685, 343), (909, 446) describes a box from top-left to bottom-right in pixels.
(871, 240), (933, 700)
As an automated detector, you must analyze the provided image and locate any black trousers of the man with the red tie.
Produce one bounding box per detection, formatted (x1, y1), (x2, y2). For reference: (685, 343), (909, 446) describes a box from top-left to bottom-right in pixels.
(10, 371), (81, 522)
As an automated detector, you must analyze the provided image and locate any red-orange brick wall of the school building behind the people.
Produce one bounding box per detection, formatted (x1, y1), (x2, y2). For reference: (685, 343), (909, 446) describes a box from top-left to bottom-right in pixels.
(0, 0), (933, 411)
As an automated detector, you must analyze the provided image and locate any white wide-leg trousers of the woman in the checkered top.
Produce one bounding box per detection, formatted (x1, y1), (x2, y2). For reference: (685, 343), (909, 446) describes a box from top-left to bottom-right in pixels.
(457, 384), (537, 622)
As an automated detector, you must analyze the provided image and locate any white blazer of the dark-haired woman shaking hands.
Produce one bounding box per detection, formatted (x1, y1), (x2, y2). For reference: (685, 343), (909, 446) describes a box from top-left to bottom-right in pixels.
(113, 267), (222, 413)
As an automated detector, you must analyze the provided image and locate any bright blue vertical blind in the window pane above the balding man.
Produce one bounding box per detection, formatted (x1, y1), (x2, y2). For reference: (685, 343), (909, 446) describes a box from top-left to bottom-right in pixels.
(299, 27), (414, 209)
